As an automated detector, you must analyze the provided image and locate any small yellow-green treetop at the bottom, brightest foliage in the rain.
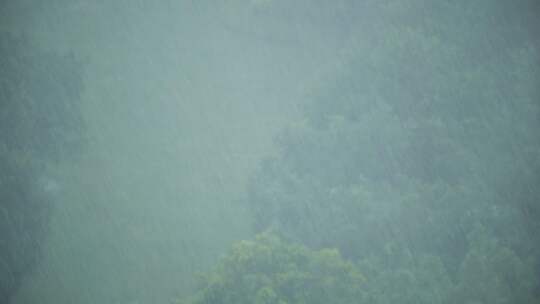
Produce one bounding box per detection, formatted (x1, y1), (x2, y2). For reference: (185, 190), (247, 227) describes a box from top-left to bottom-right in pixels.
(182, 232), (366, 304)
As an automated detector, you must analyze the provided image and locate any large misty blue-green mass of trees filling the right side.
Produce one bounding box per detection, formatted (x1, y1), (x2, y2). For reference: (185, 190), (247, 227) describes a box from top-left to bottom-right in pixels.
(246, 1), (540, 303)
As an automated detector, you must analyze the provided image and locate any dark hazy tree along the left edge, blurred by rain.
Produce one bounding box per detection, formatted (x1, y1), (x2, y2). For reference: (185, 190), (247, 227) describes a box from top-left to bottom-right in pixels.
(0, 32), (83, 303)
